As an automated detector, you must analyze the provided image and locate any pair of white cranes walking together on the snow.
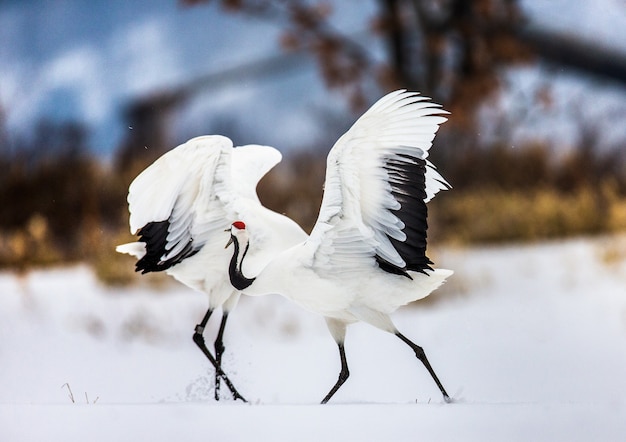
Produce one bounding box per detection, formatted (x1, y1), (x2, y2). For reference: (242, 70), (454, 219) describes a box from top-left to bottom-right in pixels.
(117, 90), (452, 403)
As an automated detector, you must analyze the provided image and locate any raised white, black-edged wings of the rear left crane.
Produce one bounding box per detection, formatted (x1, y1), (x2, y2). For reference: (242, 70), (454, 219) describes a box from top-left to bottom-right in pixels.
(118, 135), (281, 273)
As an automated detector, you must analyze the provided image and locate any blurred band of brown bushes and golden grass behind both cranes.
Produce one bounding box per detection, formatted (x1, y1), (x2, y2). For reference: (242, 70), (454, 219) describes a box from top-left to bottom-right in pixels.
(0, 114), (626, 283)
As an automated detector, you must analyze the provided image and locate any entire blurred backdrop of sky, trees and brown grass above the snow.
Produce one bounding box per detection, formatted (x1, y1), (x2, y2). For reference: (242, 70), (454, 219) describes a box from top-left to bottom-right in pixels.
(0, 0), (626, 283)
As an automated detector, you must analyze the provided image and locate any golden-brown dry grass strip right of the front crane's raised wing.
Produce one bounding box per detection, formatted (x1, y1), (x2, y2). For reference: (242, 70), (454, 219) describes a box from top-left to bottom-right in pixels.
(431, 184), (626, 244)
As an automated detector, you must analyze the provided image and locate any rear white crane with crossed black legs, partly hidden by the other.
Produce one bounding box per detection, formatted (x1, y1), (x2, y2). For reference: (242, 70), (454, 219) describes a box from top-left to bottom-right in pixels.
(116, 135), (307, 401)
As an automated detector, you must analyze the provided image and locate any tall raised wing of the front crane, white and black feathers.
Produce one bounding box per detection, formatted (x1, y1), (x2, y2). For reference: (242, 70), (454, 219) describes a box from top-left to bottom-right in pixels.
(310, 90), (450, 276)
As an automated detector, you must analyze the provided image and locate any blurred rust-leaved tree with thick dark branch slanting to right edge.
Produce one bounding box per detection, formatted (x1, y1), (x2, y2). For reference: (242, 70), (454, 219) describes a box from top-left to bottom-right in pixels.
(178, 0), (626, 180)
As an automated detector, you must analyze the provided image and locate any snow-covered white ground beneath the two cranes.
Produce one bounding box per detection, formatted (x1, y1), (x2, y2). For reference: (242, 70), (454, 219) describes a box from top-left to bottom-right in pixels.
(0, 236), (626, 442)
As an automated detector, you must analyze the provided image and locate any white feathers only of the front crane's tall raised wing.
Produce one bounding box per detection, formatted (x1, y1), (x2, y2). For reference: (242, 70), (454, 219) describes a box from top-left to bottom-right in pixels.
(310, 90), (450, 273)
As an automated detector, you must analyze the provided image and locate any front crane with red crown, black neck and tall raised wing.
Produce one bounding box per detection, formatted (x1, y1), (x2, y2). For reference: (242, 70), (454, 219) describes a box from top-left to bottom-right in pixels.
(227, 91), (452, 403)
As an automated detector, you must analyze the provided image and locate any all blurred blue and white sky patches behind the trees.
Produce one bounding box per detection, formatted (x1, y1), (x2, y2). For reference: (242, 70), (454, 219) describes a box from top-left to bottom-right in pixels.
(0, 0), (626, 157)
